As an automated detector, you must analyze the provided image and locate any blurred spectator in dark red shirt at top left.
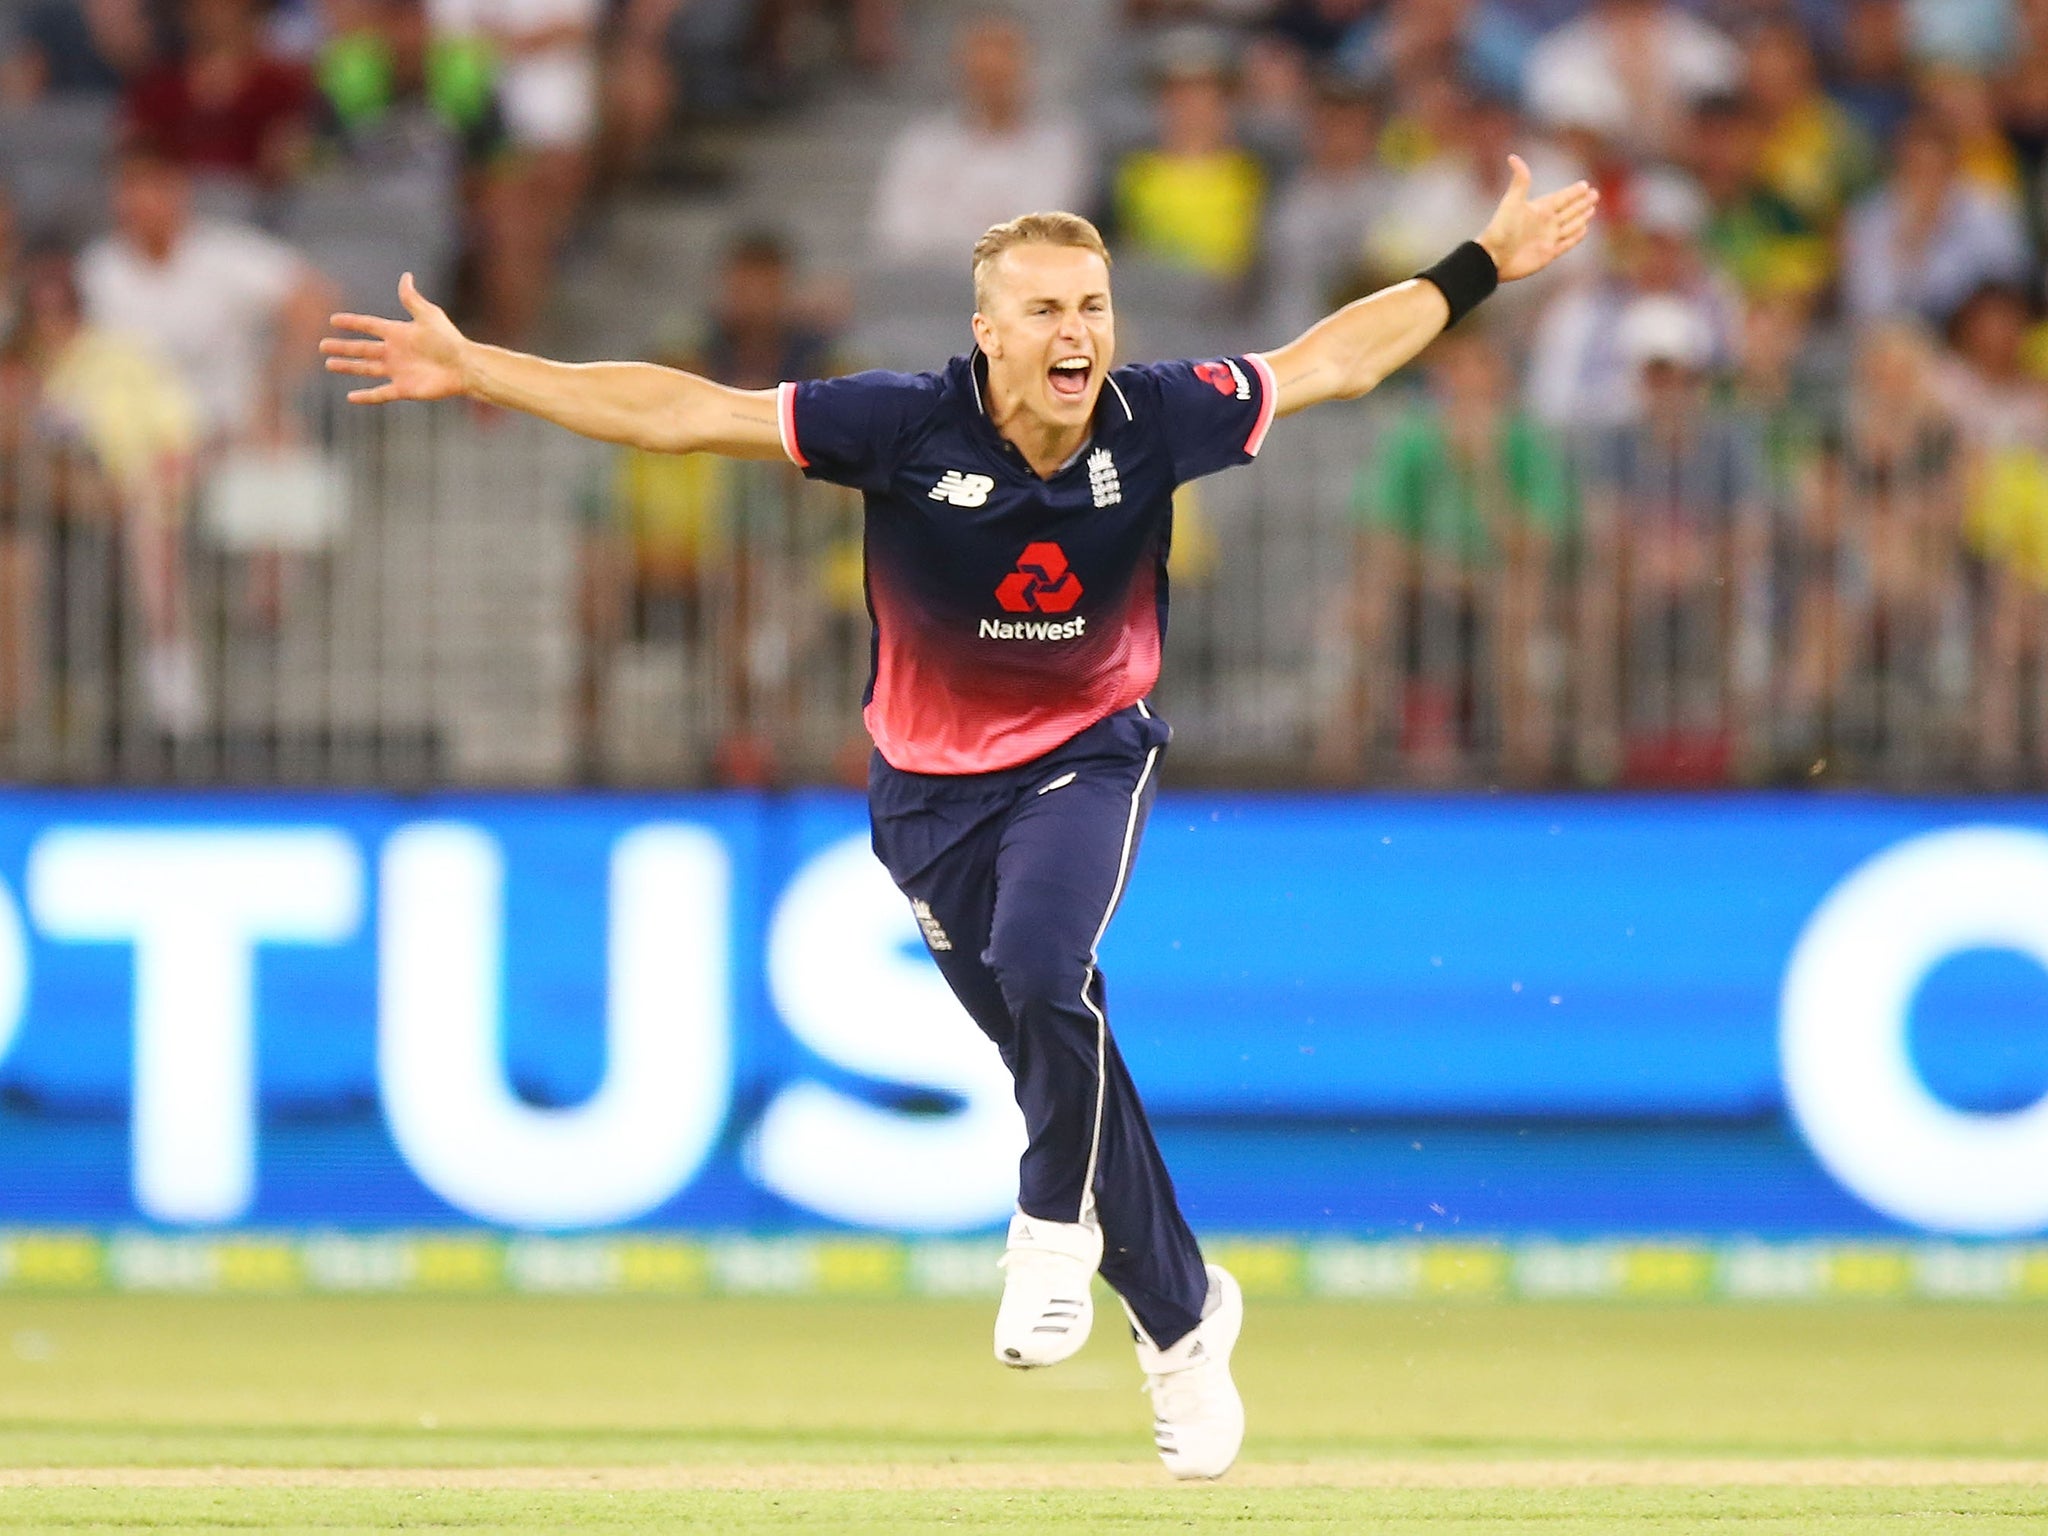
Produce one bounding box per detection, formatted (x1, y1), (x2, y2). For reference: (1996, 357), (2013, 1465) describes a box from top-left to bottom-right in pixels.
(125, 0), (311, 188)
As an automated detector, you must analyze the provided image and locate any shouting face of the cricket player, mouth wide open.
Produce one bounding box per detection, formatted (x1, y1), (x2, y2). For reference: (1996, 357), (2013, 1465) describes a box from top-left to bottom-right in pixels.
(975, 246), (1116, 426)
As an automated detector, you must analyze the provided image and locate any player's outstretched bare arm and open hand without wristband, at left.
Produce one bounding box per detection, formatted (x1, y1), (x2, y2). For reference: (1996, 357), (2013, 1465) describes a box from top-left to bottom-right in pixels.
(319, 272), (784, 459)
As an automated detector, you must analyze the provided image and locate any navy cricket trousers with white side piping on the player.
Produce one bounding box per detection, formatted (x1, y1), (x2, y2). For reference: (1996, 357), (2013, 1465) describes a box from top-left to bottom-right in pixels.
(868, 705), (1208, 1348)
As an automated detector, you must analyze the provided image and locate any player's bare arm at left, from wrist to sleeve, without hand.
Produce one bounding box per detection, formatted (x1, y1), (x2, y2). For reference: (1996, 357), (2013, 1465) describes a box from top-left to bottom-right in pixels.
(461, 342), (780, 459)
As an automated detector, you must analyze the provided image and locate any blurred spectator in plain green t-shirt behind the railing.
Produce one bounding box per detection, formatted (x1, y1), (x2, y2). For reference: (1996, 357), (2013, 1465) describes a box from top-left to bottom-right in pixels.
(1352, 328), (1575, 780)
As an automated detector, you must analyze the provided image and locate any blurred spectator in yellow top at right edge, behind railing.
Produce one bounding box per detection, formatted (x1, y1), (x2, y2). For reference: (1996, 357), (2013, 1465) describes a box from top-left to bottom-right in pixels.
(1935, 285), (2048, 784)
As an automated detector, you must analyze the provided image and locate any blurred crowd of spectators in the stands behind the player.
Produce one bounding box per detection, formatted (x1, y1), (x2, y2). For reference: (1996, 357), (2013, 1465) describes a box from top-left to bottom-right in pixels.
(0, 0), (2048, 784)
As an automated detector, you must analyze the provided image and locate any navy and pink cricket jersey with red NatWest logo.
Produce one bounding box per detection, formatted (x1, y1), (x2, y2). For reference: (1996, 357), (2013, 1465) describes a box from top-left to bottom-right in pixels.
(780, 352), (1276, 774)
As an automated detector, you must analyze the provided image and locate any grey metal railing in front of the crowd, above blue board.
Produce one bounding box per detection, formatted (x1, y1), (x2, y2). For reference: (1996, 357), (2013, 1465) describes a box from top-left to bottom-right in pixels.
(0, 385), (2048, 788)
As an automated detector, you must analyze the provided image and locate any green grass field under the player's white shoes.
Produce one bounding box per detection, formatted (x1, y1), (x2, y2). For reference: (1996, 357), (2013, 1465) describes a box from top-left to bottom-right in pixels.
(0, 1296), (2048, 1536)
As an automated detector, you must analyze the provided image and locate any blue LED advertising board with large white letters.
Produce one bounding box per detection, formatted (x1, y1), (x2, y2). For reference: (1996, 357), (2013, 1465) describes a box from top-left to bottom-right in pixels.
(0, 791), (2048, 1237)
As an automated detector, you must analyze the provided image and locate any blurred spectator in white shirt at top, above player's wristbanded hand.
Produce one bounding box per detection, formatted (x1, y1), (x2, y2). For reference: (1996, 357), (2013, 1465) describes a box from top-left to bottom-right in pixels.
(1526, 0), (1743, 160)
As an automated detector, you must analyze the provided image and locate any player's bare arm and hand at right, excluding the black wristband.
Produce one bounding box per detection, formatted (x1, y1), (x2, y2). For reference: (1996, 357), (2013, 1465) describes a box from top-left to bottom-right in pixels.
(1266, 156), (1599, 416)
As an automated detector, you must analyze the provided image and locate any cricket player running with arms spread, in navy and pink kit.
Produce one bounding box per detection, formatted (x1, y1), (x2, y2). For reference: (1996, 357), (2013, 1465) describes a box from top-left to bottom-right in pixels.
(319, 158), (1597, 1477)
